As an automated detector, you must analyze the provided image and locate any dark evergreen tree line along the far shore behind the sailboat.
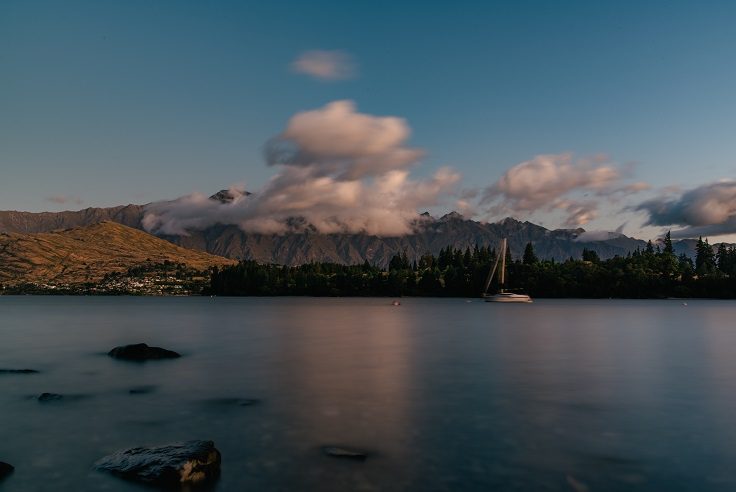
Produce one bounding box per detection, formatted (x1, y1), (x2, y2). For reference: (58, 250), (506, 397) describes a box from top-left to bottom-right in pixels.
(204, 233), (736, 298)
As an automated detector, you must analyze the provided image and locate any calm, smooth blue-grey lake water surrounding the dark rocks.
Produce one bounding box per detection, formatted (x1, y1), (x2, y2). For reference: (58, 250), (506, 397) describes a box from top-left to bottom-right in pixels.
(0, 297), (736, 492)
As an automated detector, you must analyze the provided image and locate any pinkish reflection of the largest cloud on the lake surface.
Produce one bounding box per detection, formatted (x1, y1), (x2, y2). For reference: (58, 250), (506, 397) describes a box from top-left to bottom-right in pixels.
(258, 300), (416, 490)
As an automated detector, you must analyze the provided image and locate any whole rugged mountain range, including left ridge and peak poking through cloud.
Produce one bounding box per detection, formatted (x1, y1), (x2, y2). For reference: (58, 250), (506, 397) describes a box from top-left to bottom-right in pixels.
(0, 190), (716, 266)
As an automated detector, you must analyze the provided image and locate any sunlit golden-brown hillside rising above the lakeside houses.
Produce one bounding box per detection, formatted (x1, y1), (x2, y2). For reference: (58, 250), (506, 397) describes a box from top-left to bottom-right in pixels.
(0, 221), (234, 285)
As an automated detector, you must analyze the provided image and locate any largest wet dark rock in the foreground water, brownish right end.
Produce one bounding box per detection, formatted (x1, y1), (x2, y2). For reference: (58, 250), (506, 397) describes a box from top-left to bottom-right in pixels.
(95, 441), (220, 487)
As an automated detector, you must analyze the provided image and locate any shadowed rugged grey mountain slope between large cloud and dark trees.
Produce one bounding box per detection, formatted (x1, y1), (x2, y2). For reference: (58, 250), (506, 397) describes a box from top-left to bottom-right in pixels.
(157, 214), (646, 266)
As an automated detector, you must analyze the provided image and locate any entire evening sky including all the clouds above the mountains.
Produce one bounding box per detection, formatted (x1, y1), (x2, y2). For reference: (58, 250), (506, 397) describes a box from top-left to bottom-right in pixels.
(0, 0), (736, 238)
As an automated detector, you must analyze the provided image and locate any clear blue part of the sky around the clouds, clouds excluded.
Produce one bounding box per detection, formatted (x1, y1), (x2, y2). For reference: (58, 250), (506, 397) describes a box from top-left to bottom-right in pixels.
(0, 0), (736, 235)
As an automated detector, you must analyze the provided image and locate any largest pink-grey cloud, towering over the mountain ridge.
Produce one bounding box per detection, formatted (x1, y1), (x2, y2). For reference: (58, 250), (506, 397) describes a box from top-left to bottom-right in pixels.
(143, 101), (460, 236)
